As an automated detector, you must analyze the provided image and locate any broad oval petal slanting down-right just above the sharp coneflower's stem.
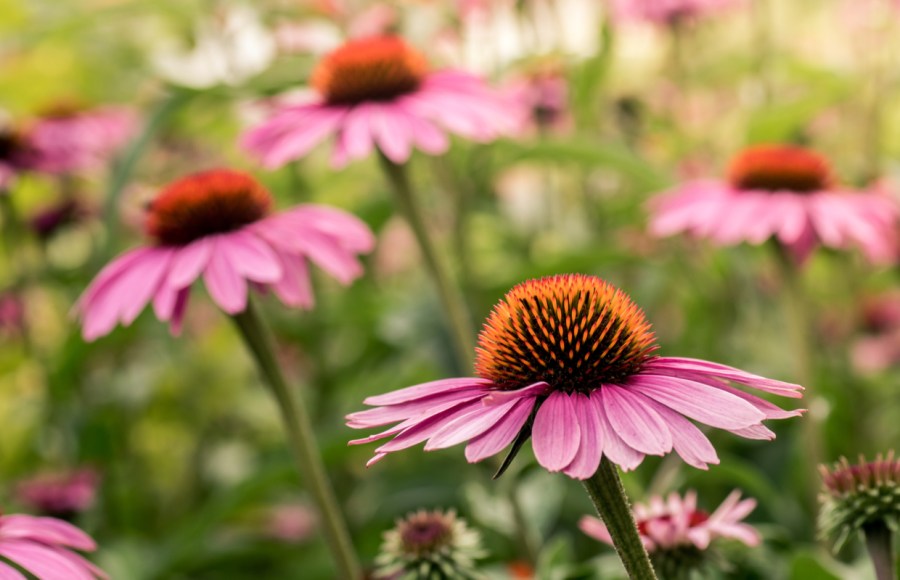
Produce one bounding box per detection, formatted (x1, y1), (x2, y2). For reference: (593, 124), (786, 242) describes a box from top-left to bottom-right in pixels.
(601, 385), (672, 455)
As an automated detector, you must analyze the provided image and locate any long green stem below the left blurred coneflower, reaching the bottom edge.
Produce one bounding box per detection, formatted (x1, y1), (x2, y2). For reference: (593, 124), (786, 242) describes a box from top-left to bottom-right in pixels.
(233, 301), (362, 580)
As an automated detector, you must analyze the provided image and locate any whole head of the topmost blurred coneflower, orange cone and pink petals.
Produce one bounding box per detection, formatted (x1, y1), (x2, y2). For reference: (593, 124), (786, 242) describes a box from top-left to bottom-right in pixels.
(243, 36), (517, 168)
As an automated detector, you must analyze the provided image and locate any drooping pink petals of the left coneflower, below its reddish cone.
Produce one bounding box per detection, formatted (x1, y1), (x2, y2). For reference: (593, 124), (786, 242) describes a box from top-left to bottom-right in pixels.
(75, 205), (375, 340)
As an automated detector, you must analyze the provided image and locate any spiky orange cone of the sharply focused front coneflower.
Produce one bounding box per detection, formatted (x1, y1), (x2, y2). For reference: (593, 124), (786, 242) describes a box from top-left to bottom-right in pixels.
(475, 274), (656, 393)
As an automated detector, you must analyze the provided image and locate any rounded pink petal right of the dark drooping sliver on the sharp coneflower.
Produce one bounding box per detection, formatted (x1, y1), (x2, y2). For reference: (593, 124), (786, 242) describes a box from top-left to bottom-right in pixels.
(531, 391), (581, 472)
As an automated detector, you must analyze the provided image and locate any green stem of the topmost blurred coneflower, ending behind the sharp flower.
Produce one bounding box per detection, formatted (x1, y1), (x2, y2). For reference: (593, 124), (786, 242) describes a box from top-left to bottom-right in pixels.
(378, 152), (474, 366)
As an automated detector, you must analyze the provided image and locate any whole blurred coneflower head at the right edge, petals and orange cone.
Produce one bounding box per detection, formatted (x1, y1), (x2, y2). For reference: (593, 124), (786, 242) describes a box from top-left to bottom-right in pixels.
(650, 145), (900, 263)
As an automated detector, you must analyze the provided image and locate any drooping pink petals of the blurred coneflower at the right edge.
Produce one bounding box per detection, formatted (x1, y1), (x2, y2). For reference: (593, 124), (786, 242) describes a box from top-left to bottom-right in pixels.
(650, 180), (900, 264)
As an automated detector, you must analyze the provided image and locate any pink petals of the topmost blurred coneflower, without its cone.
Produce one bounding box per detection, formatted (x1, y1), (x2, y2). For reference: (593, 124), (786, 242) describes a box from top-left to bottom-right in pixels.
(242, 70), (522, 169)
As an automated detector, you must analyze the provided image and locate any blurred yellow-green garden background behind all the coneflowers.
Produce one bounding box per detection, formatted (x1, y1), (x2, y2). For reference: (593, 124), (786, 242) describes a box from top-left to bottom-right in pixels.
(0, 0), (900, 580)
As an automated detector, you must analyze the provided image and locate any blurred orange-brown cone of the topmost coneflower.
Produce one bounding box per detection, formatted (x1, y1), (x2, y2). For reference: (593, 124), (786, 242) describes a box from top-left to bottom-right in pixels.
(312, 36), (428, 104)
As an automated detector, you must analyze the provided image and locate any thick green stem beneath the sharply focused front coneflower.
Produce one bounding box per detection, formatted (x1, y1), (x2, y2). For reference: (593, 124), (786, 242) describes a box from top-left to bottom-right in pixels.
(582, 457), (656, 580)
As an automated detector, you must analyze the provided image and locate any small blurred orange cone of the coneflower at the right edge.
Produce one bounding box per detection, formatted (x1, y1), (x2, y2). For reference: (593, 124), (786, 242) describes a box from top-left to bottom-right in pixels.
(728, 145), (833, 193)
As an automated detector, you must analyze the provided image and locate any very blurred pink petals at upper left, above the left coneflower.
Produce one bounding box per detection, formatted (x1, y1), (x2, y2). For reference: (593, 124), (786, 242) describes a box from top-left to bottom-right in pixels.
(29, 103), (135, 174)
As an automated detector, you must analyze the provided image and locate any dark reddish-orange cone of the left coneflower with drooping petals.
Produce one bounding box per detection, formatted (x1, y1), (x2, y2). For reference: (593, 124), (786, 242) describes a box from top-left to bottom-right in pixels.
(147, 169), (272, 246)
